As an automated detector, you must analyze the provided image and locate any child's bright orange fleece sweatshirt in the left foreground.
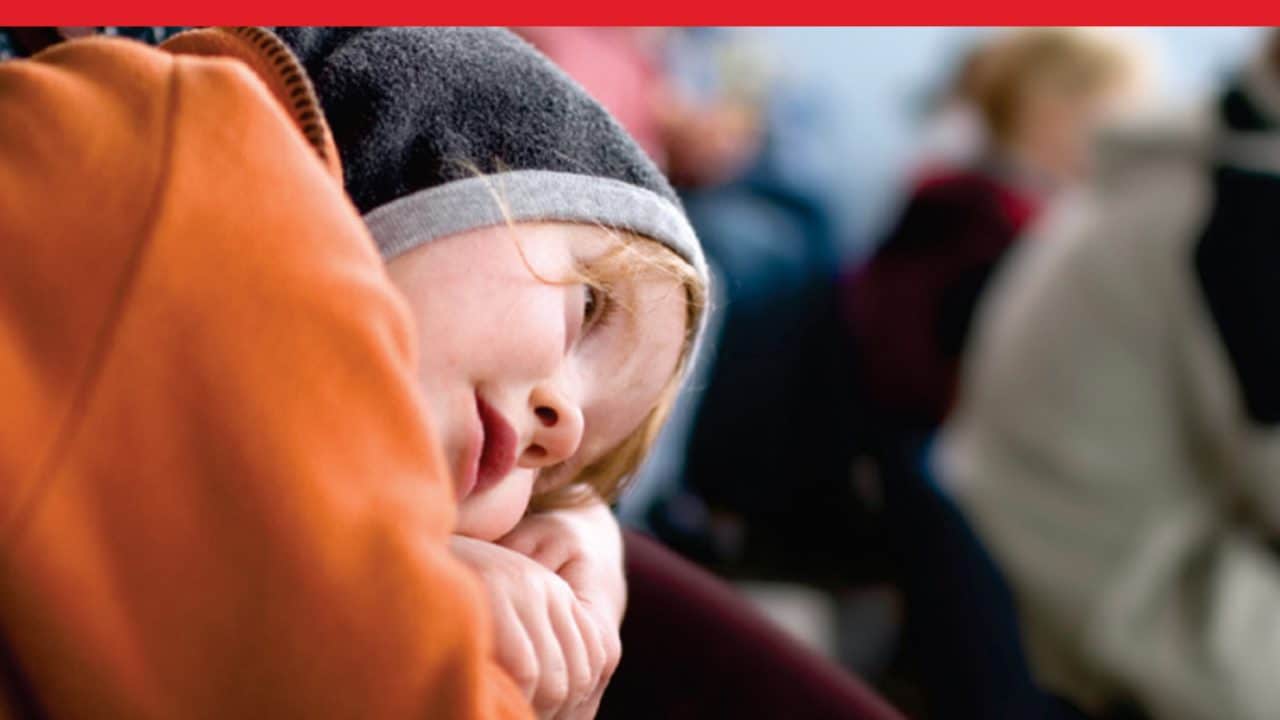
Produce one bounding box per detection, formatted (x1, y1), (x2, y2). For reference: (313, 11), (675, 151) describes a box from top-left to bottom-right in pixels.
(0, 31), (529, 719)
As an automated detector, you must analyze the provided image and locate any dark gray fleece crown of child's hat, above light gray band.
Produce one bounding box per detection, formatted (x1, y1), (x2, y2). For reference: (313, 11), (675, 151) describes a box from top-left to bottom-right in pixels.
(279, 27), (677, 213)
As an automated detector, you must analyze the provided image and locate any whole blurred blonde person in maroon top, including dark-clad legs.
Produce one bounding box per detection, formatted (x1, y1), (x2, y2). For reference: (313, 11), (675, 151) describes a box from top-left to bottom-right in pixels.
(844, 28), (1147, 720)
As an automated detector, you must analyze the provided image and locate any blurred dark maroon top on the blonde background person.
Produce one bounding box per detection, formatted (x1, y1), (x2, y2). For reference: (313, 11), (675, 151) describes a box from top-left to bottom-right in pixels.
(845, 170), (1039, 428)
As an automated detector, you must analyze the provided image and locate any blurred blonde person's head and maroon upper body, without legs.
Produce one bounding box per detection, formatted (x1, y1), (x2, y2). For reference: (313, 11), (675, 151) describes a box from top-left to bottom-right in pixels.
(845, 28), (1140, 445)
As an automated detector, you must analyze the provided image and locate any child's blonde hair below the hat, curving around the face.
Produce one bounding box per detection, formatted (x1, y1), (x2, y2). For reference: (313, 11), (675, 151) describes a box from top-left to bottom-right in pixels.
(529, 231), (707, 512)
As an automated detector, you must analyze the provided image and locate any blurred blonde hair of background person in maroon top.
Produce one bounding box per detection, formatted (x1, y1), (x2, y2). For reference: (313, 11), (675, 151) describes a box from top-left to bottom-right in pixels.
(974, 28), (1146, 142)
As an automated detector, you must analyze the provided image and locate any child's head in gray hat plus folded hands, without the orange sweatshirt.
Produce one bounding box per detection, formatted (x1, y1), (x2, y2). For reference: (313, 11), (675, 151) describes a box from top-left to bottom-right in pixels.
(282, 28), (707, 716)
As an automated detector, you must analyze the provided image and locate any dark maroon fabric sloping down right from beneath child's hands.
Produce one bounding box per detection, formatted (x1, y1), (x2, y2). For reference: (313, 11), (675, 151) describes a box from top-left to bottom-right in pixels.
(599, 532), (902, 720)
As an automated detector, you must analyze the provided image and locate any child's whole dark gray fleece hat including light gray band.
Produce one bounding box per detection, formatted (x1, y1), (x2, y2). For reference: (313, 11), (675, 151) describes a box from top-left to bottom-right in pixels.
(276, 27), (707, 281)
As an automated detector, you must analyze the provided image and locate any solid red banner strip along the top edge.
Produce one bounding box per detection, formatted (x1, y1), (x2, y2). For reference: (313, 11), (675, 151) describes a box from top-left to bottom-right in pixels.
(0, 0), (1280, 26)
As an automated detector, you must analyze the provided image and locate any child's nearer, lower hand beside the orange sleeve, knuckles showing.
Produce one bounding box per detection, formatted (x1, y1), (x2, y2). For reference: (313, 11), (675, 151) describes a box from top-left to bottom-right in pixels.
(452, 536), (618, 720)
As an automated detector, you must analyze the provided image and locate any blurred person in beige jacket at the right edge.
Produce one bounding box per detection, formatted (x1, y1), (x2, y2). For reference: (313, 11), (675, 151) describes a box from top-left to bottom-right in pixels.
(936, 33), (1280, 720)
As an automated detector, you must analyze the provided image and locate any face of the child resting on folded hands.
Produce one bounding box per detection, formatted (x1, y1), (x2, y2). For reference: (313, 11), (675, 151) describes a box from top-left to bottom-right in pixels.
(388, 223), (686, 539)
